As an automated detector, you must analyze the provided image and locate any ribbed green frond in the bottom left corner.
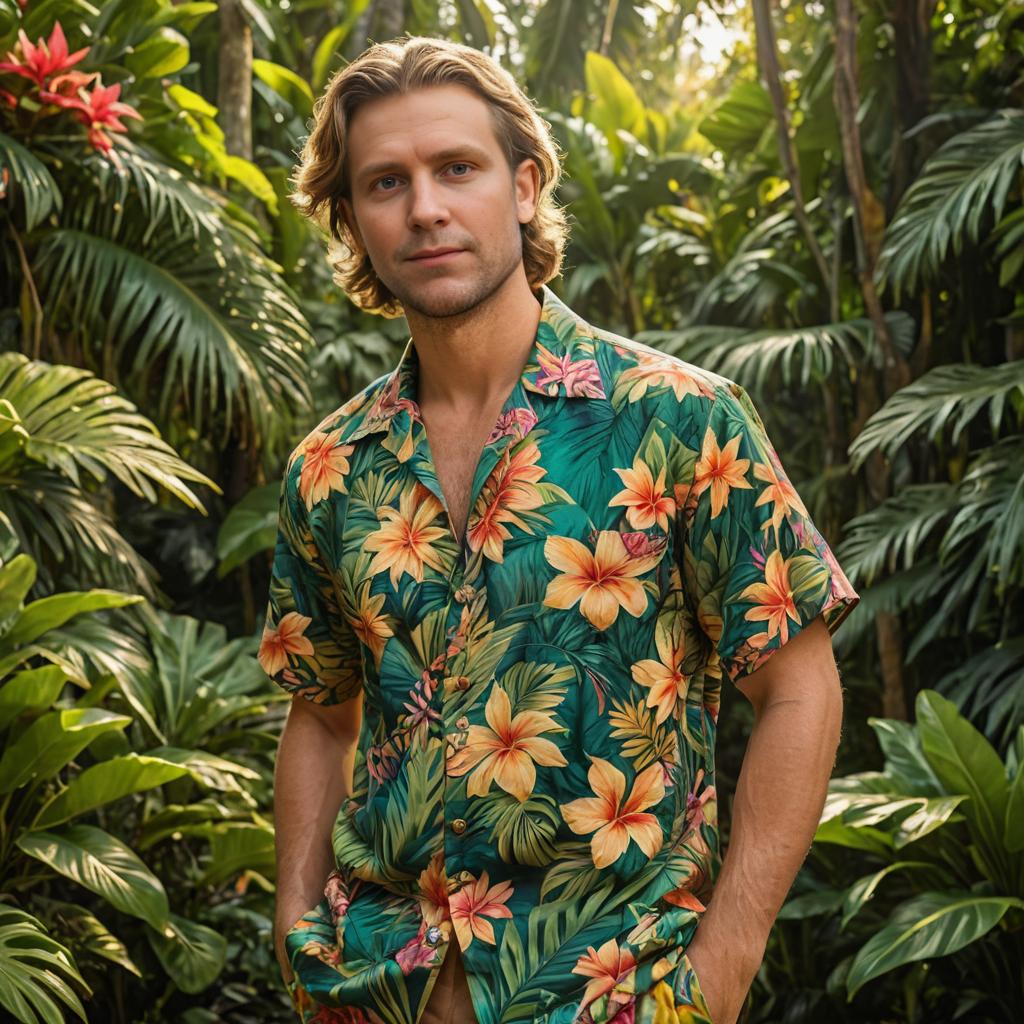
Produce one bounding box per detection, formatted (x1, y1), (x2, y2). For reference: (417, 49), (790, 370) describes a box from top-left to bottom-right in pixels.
(0, 906), (91, 1024)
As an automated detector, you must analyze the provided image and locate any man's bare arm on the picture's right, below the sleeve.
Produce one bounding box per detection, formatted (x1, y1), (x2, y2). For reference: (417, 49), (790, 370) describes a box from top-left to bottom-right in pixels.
(686, 616), (843, 1024)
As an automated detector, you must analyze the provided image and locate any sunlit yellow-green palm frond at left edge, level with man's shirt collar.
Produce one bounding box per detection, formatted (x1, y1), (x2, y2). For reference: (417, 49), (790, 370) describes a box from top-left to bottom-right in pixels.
(0, 352), (220, 515)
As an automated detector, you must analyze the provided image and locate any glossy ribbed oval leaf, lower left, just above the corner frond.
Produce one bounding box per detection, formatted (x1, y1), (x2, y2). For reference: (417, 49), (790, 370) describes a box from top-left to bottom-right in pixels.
(16, 825), (170, 931)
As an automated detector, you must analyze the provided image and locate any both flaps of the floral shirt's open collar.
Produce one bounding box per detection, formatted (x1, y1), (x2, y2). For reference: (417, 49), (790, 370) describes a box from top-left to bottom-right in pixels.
(347, 285), (607, 450)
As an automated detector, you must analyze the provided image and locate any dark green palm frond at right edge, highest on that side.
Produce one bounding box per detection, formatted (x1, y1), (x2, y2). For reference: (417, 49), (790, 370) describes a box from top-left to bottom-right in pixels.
(878, 109), (1024, 303)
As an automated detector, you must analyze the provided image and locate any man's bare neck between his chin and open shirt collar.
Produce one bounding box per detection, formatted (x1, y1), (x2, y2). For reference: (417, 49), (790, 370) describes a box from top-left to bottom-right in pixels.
(407, 268), (541, 414)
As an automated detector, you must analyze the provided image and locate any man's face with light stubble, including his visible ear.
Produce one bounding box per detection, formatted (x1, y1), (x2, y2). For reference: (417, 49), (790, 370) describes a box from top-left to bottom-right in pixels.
(342, 85), (540, 317)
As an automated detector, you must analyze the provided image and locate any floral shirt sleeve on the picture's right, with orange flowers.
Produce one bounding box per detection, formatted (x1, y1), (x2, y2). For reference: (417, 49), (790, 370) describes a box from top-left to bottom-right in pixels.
(679, 383), (859, 682)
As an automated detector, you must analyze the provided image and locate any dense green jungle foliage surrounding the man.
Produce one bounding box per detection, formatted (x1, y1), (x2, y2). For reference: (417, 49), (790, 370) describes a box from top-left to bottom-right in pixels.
(0, 0), (1024, 1024)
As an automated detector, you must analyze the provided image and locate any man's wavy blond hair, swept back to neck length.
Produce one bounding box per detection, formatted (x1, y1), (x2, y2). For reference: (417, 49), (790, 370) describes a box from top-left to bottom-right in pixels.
(289, 36), (568, 316)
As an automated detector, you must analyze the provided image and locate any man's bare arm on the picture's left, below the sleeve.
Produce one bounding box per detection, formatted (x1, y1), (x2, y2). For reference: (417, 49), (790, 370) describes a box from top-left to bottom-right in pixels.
(273, 693), (362, 980)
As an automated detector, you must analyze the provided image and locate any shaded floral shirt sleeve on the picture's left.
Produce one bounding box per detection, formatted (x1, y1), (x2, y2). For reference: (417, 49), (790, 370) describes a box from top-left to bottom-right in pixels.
(257, 463), (362, 705)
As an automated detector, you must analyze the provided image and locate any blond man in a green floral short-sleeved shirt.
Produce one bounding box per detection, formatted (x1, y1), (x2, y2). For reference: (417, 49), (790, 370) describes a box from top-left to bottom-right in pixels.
(260, 32), (857, 1024)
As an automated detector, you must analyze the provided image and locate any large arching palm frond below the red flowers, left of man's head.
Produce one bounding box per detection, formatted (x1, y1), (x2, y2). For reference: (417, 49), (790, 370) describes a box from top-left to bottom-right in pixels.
(34, 144), (314, 450)
